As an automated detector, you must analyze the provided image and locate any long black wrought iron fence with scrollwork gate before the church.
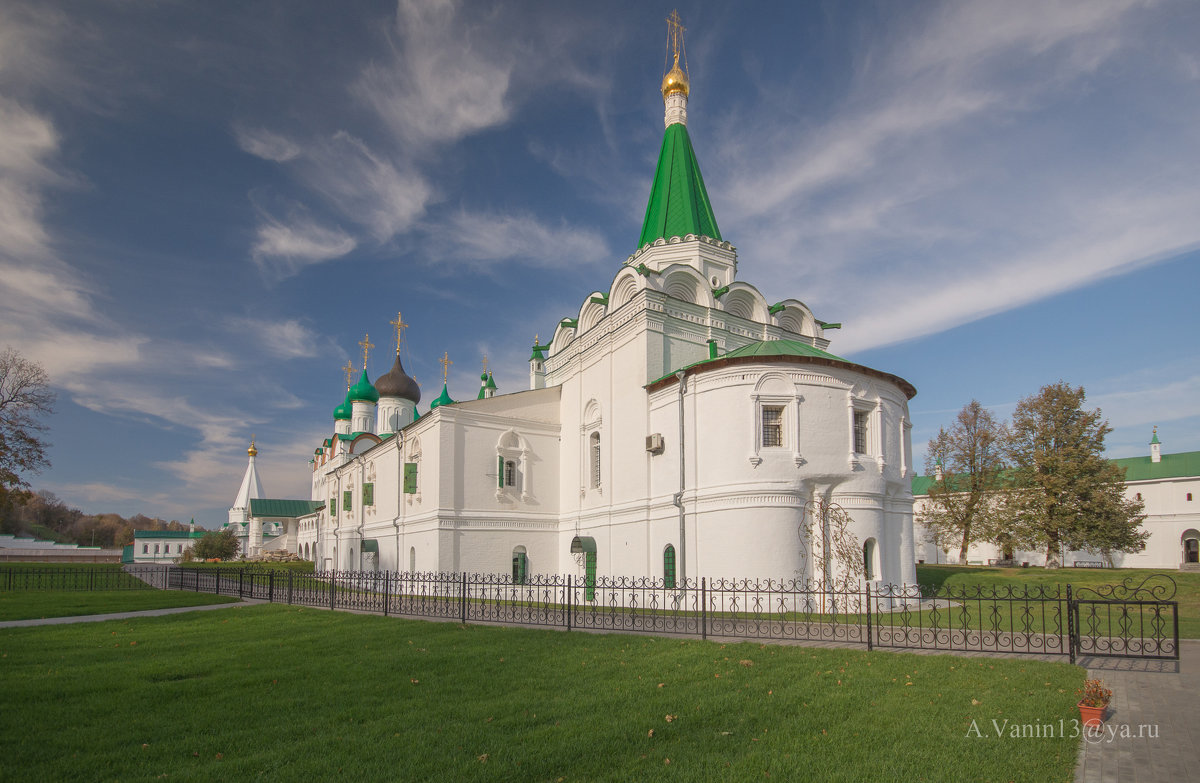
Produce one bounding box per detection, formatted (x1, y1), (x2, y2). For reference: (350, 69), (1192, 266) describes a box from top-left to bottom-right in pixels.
(0, 566), (1180, 662)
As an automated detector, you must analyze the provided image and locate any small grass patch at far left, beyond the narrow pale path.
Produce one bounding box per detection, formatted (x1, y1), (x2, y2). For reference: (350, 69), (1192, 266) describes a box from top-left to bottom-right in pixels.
(0, 590), (238, 621)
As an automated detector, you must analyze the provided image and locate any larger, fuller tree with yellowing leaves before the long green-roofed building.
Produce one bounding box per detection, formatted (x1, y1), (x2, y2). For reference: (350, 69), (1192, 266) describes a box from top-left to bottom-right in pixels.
(1008, 381), (1150, 568)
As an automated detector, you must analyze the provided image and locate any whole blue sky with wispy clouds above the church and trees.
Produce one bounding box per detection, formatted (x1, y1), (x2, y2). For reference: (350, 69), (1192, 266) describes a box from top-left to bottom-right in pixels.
(0, 0), (1200, 527)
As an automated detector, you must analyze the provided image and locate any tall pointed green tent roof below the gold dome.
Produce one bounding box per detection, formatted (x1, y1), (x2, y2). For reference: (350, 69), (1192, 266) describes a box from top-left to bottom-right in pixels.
(637, 122), (721, 247)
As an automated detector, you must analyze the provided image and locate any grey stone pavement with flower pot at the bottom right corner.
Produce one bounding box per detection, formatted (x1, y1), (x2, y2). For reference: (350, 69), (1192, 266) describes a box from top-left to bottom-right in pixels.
(1075, 640), (1200, 783)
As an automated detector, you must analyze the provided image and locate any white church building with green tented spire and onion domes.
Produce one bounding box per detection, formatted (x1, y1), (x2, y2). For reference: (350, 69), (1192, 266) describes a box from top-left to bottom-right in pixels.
(229, 21), (916, 584)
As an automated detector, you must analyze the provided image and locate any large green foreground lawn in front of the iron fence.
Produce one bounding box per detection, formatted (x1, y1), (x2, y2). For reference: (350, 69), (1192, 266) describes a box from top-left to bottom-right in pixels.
(0, 605), (1084, 782)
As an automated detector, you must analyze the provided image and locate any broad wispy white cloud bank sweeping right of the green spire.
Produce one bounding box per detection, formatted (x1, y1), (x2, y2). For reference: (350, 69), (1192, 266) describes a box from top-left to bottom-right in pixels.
(714, 0), (1200, 352)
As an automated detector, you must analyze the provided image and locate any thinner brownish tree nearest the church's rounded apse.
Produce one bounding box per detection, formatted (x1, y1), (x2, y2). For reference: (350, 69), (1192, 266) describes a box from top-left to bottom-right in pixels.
(920, 400), (1008, 563)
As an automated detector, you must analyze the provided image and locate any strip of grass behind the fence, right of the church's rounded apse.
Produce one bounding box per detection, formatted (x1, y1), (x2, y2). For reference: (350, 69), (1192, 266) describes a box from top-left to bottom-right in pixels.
(917, 564), (1200, 639)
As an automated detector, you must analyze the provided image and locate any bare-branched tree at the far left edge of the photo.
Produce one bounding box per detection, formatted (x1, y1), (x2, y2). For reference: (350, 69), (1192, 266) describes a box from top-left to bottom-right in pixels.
(0, 347), (54, 509)
